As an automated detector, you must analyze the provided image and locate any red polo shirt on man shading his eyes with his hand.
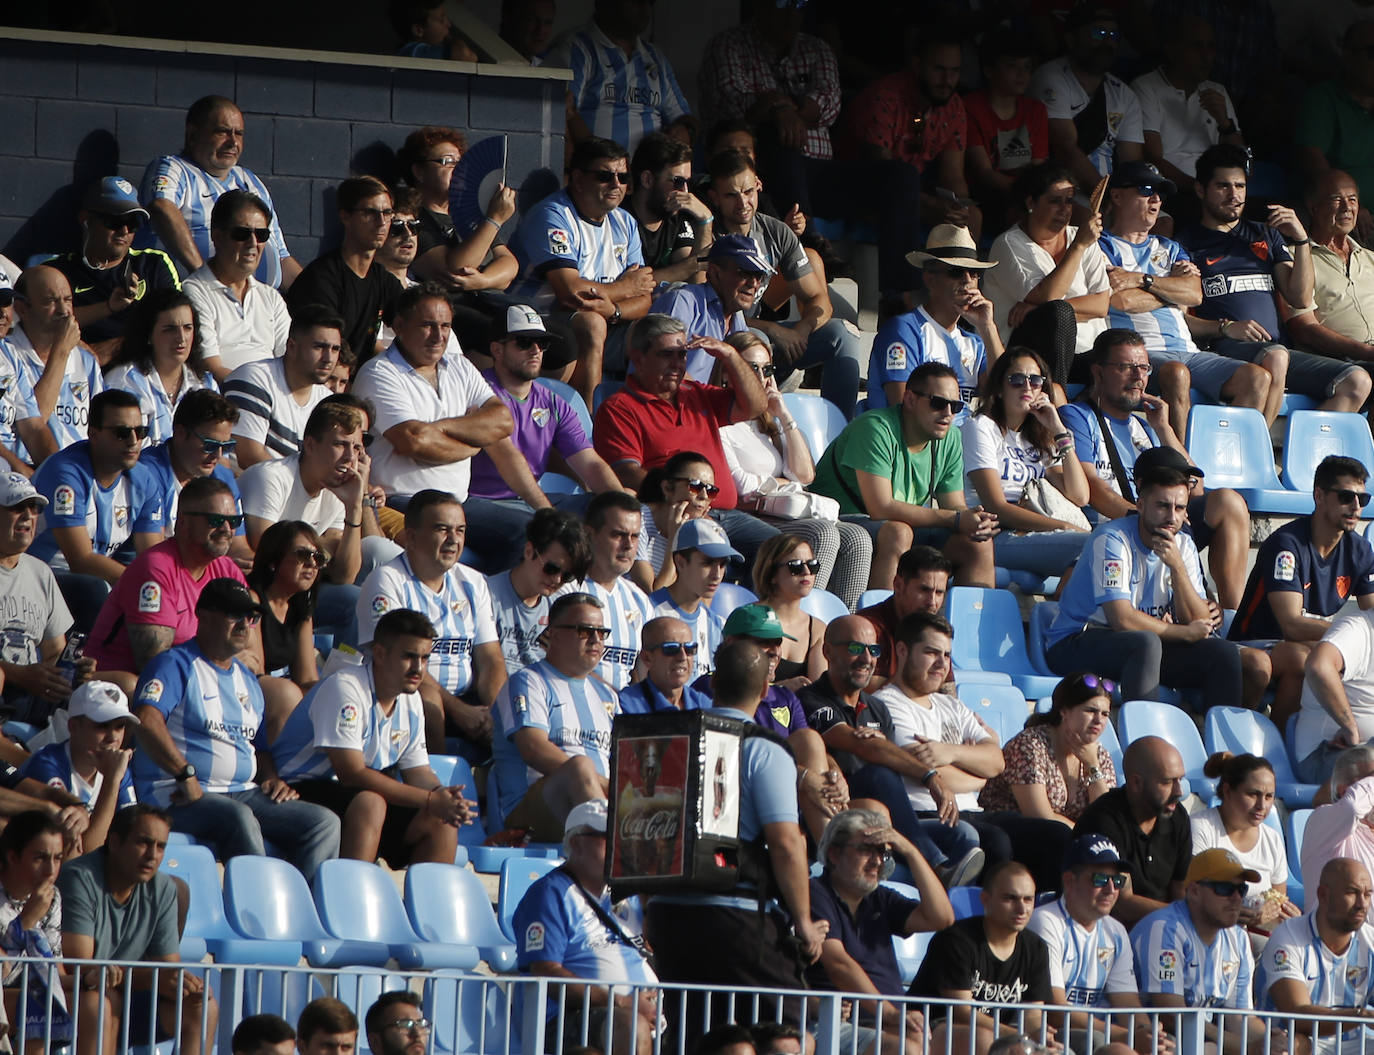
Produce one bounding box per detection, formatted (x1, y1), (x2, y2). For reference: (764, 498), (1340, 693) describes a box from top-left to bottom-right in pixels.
(592, 375), (739, 510)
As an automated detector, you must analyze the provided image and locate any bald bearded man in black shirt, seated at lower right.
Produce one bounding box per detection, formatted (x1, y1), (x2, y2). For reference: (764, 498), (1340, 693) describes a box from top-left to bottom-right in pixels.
(1073, 736), (1193, 927)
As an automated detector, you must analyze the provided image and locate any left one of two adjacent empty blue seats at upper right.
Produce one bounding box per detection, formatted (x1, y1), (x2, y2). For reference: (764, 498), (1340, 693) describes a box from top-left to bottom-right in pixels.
(1187, 405), (1312, 517)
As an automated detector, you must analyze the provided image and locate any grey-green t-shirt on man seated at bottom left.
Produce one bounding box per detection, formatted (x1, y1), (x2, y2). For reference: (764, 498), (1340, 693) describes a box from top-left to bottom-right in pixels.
(58, 848), (179, 960)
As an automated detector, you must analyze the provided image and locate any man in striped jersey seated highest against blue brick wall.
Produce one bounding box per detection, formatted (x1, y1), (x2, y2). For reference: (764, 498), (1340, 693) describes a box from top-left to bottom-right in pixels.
(139, 95), (301, 290)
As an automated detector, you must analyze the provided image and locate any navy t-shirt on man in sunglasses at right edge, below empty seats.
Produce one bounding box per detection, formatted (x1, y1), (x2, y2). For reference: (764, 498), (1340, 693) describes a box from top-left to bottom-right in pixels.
(1227, 517), (1374, 642)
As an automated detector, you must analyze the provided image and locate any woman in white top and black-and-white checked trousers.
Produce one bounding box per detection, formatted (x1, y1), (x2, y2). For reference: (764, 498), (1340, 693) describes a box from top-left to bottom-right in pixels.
(712, 330), (872, 609)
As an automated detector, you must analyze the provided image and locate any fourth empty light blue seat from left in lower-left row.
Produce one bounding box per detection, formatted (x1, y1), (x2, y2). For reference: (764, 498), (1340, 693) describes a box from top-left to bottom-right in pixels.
(405, 863), (515, 971)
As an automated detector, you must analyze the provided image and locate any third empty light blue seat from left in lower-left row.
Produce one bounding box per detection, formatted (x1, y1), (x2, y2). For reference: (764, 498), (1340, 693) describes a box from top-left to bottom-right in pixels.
(315, 860), (481, 971)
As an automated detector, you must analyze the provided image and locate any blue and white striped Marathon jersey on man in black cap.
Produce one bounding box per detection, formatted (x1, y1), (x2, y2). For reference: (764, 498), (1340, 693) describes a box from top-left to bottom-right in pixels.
(133, 639), (262, 808)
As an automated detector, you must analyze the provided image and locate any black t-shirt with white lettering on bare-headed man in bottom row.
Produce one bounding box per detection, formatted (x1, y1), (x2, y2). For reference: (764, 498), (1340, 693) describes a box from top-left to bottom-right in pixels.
(907, 916), (1052, 1025)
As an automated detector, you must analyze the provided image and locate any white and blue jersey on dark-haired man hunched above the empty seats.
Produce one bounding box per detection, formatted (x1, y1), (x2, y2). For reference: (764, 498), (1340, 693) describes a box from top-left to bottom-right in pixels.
(272, 659), (429, 783)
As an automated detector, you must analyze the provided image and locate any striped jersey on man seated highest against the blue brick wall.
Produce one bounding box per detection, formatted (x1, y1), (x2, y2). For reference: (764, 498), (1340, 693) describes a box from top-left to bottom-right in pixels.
(135, 154), (291, 288)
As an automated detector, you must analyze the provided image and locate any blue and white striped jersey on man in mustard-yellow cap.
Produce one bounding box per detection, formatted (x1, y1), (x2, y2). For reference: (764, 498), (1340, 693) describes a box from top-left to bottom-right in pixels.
(1131, 901), (1254, 1011)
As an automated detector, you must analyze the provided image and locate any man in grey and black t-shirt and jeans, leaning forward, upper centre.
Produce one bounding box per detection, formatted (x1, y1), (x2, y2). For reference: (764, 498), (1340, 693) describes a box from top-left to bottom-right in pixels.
(708, 150), (857, 418)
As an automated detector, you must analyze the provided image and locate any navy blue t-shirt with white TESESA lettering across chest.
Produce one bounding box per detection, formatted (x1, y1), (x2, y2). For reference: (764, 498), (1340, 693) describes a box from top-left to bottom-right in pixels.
(1178, 220), (1293, 341)
